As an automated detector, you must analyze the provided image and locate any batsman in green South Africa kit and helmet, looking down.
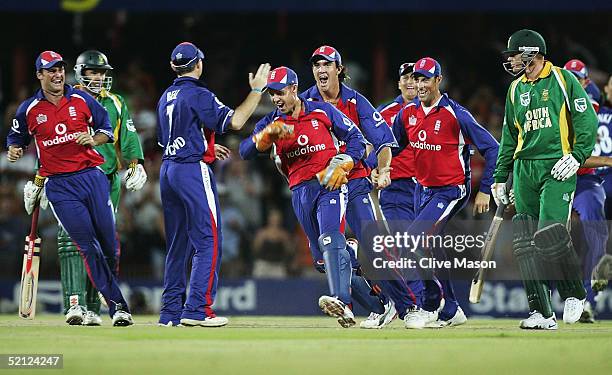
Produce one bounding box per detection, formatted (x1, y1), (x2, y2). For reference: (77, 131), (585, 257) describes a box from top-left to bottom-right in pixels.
(492, 29), (597, 330)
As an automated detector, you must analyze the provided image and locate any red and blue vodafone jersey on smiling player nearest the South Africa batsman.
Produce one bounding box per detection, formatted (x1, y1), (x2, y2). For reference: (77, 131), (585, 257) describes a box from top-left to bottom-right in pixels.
(393, 94), (499, 194)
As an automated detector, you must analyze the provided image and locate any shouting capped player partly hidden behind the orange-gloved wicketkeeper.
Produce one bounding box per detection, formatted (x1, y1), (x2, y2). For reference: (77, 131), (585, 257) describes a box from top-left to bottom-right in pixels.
(302, 46), (422, 329)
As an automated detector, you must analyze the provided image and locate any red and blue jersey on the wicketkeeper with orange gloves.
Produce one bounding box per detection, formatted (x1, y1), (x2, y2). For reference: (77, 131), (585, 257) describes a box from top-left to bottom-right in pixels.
(240, 98), (366, 188)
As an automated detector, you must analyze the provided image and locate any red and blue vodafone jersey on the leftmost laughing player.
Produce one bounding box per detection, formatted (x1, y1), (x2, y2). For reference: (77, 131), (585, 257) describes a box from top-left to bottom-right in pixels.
(7, 85), (114, 176)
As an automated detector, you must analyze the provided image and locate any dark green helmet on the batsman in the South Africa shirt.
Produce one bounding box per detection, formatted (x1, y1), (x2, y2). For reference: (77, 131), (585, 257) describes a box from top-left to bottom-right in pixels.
(502, 29), (546, 76)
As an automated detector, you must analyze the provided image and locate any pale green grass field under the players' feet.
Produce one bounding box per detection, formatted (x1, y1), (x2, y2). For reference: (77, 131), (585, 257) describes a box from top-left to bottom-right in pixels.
(0, 315), (612, 375)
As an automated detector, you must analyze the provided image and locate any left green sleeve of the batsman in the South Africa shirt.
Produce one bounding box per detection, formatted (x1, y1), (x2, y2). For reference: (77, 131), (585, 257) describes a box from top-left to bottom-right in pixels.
(493, 85), (519, 182)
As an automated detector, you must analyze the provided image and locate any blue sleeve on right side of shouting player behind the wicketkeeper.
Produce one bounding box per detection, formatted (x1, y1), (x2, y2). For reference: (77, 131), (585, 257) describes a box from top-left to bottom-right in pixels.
(357, 93), (398, 154)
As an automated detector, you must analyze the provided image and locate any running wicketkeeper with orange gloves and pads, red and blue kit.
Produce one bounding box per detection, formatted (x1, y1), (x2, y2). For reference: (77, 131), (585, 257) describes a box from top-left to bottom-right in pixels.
(240, 66), (366, 328)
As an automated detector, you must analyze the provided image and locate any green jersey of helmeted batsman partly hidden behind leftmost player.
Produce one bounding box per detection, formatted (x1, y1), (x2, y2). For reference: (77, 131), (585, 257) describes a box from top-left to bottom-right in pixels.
(76, 89), (144, 174)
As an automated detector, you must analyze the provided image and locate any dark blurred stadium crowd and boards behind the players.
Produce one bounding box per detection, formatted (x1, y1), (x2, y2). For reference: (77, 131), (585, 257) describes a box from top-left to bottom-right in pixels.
(0, 0), (612, 316)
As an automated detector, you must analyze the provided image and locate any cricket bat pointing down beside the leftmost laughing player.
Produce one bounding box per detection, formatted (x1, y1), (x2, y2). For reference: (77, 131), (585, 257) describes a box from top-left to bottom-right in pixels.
(19, 205), (40, 319)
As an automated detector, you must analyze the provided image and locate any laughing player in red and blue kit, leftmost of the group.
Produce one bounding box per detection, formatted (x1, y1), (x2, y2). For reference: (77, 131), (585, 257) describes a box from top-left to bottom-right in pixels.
(7, 51), (133, 326)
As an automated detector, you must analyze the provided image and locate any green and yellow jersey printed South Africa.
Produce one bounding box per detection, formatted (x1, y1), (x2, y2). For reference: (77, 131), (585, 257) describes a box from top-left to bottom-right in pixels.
(494, 61), (597, 182)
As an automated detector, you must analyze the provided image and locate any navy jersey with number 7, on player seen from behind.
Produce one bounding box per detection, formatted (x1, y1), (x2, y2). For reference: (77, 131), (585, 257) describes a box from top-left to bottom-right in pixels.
(157, 77), (234, 164)
